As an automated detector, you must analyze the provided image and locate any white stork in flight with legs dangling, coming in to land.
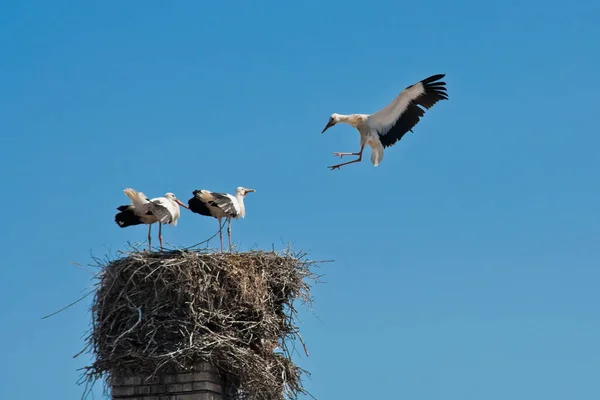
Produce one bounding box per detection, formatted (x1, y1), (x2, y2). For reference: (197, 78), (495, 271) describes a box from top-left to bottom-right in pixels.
(321, 74), (448, 171)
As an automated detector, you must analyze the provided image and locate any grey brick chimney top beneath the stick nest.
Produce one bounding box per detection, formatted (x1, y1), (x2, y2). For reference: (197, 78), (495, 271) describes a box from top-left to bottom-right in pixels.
(111, 362), (225, 400)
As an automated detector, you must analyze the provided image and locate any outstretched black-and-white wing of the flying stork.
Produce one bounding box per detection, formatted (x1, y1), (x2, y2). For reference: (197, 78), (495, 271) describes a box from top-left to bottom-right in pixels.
(367, 74), (448, 147)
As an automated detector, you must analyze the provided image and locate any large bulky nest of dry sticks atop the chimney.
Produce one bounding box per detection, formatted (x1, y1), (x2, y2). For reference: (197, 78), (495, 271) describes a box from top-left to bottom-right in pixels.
(83, 250), (318, 400)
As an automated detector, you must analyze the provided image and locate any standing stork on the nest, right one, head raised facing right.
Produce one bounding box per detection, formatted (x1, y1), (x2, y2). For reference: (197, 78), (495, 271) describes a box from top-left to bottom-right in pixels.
(188, 186), (256, 251)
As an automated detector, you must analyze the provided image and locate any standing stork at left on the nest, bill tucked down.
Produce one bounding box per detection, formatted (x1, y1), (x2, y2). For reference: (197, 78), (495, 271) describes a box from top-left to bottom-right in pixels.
(115, 188), (188, 250)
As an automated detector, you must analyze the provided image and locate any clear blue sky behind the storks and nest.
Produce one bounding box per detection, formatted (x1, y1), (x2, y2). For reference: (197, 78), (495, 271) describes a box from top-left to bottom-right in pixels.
(0, 0), (600, 400)
